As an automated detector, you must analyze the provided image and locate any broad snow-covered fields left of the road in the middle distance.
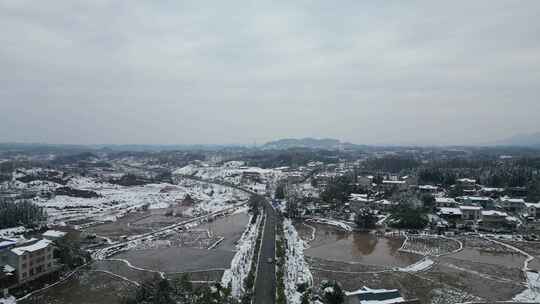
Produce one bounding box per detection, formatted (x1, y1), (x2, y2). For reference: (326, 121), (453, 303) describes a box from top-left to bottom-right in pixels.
(22, 177), (248, 224)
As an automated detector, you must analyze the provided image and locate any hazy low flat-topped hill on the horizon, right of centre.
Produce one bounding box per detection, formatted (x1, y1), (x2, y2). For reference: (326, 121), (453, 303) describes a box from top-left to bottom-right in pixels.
(262, 137), (362, 150)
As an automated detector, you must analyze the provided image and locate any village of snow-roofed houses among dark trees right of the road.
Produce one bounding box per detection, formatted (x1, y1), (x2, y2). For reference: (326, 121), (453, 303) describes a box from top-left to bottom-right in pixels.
(308, 166), (540, 232)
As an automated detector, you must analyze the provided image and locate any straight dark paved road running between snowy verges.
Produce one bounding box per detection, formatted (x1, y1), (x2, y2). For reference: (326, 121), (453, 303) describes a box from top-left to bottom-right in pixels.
(253, 199), (277, 304)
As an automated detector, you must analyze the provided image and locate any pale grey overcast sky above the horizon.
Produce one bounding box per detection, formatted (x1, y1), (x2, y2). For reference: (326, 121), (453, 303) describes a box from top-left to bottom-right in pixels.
(0, 0), (540, 144)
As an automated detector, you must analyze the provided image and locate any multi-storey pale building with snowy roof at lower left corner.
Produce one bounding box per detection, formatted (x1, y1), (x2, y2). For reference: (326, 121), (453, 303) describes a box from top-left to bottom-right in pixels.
(0, 230), (66, 289)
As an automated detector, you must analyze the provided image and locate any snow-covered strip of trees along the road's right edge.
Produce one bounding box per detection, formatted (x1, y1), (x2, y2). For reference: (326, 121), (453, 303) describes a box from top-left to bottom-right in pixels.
(283, 219), (313, 304)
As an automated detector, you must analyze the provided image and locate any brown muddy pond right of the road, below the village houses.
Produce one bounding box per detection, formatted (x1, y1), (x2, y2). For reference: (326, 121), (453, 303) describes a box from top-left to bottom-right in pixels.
(302, 224), (421, 267)
